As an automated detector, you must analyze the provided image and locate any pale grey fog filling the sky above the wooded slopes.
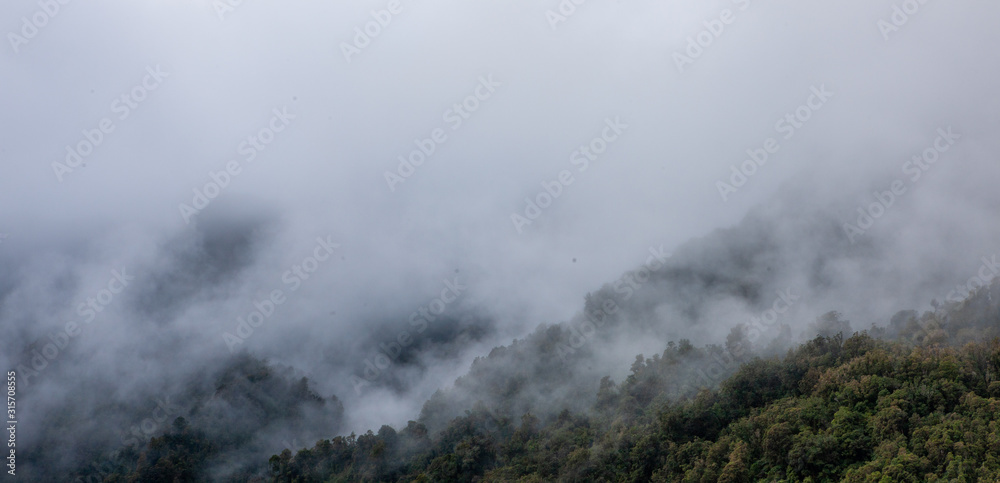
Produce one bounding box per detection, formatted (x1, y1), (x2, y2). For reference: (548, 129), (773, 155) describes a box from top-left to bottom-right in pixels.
(0, 0), (1000, 480)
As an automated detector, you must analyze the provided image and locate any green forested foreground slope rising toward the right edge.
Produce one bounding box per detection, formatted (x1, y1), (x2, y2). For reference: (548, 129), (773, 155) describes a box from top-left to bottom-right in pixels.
(84, 283), (1000, 482)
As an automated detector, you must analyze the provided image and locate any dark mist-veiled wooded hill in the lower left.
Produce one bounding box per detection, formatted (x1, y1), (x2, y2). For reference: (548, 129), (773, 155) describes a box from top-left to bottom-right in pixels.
(70, 354), (344, 482)
